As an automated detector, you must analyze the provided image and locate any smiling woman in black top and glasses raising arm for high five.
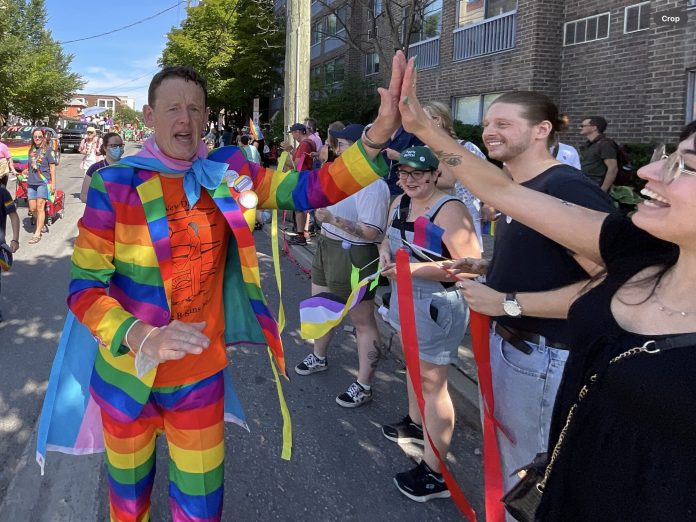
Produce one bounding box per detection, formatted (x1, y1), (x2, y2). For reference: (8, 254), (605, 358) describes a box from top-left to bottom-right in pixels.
(400, 55), (696, 521)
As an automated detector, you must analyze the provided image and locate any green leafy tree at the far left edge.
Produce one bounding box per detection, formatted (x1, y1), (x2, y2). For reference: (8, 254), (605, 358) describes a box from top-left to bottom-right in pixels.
(0, 0), (84, 122)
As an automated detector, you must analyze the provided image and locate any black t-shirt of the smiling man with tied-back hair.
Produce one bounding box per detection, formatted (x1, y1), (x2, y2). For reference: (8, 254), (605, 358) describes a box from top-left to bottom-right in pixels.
(486, 165), (615, 343)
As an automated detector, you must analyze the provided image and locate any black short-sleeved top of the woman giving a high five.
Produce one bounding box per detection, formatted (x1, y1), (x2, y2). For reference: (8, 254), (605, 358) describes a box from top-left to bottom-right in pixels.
(537, 215), (696, 522)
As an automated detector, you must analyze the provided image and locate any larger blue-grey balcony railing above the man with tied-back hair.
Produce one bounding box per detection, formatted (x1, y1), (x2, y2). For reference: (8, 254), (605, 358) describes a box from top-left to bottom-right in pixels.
(452, 11), (517, 62)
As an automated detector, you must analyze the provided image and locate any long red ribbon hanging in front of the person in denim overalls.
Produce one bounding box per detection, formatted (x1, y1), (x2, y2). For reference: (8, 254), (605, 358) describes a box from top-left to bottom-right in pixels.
(396, 248), (476, 522)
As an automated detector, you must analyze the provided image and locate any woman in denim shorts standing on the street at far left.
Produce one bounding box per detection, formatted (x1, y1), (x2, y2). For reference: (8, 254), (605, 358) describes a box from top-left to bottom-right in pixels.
(27, 128), (56, 245)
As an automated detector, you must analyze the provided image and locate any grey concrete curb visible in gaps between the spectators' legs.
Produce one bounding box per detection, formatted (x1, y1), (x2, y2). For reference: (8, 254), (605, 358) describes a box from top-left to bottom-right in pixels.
(263, 223), (479, 410)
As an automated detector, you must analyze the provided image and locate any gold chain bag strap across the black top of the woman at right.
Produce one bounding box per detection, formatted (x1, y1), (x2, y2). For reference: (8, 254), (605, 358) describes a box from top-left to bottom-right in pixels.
(537, 333), (696, 493)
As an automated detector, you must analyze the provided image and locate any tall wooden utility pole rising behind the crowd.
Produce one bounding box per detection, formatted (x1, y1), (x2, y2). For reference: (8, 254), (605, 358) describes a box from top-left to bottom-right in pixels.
(283, 0), (312, 138)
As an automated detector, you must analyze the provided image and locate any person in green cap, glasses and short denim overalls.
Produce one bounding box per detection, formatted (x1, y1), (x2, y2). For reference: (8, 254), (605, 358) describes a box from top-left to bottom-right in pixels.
(379, 147), (481, 502)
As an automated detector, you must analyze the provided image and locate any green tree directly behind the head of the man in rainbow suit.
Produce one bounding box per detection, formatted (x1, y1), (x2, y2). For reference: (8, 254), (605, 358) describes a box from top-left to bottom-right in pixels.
(160, 0), (285, 118)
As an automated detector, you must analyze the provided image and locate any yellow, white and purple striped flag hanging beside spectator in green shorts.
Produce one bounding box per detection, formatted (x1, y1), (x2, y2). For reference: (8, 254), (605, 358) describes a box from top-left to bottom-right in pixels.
(300, 271), (380, 339)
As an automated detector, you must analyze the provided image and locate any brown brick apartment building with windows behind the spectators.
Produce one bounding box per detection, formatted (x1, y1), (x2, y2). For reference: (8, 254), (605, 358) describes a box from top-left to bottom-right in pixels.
(271, 0), (696, 143)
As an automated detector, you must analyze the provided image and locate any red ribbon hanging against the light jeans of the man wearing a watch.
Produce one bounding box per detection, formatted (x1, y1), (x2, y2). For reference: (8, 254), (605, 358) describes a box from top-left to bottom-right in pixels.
(469, 310), (505, 522)
